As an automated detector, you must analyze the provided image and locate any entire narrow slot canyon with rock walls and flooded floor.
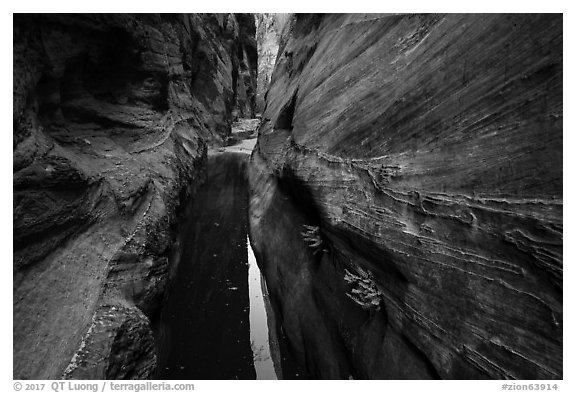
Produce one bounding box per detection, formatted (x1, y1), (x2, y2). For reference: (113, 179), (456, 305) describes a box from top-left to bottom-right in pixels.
(13, 13), (563, 380)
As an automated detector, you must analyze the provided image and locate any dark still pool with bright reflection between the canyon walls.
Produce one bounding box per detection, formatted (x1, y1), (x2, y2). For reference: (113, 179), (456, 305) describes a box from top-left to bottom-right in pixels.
(154, 153), (277, 380)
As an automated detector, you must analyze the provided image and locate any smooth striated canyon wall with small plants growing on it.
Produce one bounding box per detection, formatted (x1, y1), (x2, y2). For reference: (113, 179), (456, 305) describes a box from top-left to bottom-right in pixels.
(250, 14), (563, 379)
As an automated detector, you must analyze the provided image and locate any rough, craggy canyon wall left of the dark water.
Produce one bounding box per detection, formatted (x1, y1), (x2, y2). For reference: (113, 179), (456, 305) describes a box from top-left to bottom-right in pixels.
(13, 14), (256, 379)
